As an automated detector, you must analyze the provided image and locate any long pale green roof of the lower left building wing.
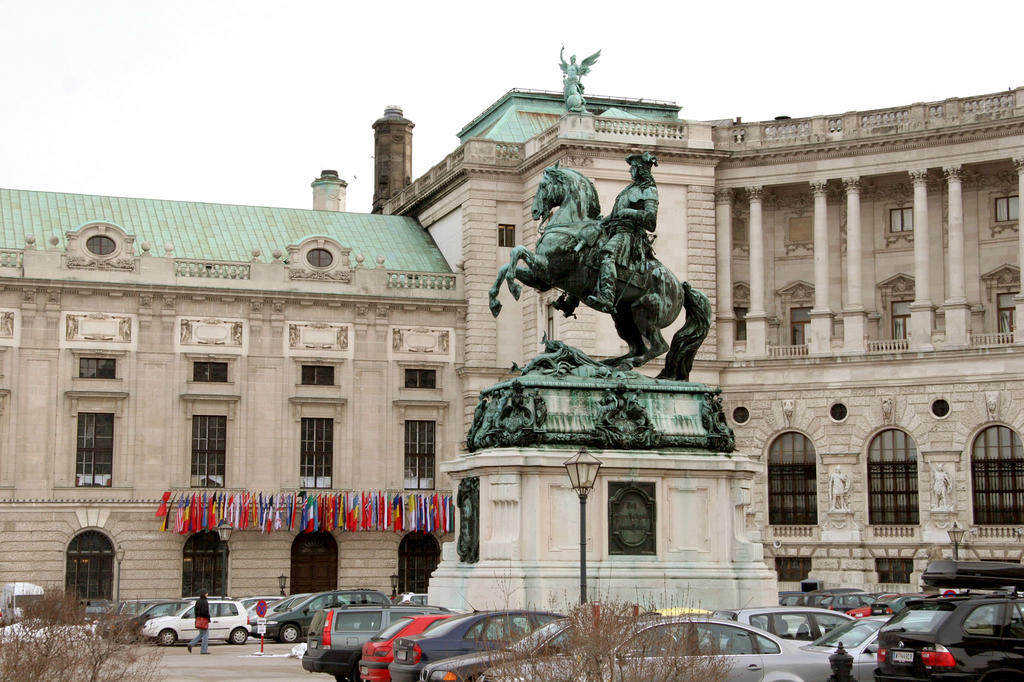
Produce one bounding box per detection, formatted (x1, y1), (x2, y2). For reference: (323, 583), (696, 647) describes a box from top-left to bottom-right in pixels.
(0, 188), (452, 272)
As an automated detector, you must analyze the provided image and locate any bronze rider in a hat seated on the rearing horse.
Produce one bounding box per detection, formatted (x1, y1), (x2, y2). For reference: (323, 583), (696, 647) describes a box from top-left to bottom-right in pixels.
(587, 152), (657, 312)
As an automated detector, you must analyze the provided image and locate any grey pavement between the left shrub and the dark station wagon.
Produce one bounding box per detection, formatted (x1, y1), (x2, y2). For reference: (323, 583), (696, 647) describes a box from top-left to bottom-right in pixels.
(153, 639), (315, 682)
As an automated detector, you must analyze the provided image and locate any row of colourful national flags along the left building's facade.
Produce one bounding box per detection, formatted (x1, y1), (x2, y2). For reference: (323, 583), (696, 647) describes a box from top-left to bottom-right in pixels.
(157, 491), (455, 535)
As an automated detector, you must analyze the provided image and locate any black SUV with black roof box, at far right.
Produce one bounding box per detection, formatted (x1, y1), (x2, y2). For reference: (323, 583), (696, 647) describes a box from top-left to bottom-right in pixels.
(874, 561), (1024, 682)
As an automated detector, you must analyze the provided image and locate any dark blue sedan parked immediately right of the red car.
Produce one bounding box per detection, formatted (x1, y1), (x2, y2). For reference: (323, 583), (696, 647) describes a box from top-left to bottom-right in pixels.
(388, 610), (562, 682)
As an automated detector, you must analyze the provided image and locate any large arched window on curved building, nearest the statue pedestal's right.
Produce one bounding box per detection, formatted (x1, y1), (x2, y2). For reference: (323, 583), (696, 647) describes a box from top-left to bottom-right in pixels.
(768, 431), (818, 525)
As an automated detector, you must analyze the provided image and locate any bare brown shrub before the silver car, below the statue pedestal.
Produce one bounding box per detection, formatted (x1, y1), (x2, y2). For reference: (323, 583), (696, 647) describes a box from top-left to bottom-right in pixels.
(484, 602), (729, 682)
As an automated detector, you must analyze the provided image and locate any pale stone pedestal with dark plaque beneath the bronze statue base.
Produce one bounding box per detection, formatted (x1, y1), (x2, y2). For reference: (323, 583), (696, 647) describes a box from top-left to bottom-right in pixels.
(429, 445), (777, 609)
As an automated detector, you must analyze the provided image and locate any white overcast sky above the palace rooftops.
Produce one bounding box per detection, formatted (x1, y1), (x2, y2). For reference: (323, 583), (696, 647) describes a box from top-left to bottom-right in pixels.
(0, 0), (1024, 212)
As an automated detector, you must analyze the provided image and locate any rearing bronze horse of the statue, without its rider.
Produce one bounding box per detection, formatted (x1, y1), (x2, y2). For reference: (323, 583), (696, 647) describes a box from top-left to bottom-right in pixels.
(488, 164), (711, 381)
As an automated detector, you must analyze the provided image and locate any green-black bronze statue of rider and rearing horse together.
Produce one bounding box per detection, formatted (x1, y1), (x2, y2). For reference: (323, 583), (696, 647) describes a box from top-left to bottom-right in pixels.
(488, 152), (712, 381)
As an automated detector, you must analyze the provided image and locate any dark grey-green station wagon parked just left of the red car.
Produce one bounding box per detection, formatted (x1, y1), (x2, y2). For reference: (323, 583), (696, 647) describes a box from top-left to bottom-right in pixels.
(302, 604), (446, 682)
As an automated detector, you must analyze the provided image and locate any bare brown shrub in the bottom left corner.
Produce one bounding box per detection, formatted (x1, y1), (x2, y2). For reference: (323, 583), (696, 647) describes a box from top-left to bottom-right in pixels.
(0, 591), (163, 682)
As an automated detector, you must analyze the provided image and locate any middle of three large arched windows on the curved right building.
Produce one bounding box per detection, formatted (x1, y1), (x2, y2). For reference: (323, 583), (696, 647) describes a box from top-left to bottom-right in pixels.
(867, 429), (918, 525)
